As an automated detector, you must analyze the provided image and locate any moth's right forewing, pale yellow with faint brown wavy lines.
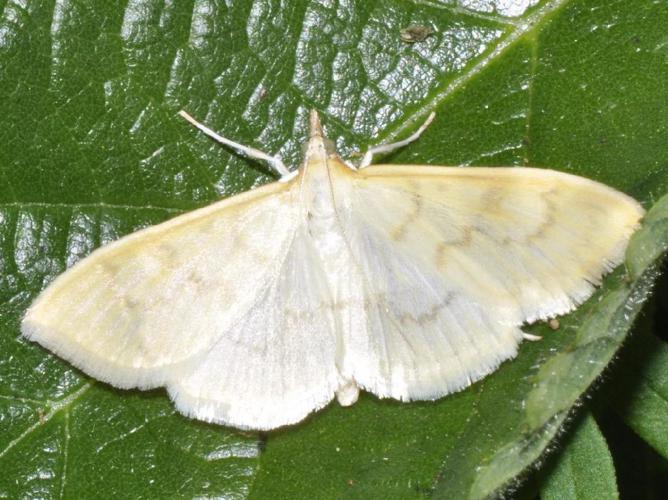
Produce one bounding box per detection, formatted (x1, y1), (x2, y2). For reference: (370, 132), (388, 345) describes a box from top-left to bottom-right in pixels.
(354, 165), (644, 321)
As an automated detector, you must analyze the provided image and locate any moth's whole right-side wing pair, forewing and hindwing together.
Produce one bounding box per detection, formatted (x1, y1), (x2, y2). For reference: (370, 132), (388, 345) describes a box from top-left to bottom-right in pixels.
(338, 165), (643, 399)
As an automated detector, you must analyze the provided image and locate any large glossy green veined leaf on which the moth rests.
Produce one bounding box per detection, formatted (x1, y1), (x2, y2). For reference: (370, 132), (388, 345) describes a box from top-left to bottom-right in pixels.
(0, 0), (668, 498)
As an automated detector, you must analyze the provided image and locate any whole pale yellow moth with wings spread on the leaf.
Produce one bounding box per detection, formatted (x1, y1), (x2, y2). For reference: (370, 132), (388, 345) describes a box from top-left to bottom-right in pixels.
(21, 111), (643, 429)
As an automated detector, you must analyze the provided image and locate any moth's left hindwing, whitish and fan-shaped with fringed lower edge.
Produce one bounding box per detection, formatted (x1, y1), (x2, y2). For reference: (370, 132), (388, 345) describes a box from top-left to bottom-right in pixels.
(168, 227), (340, 430)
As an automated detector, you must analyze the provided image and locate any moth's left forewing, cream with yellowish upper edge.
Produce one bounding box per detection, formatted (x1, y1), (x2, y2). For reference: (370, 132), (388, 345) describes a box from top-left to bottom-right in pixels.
(21, 183), (297, 388)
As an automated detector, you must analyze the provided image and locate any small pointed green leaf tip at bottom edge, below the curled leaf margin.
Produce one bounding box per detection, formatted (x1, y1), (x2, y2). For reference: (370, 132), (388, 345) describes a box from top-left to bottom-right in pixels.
(540, 413), (619, 500)
